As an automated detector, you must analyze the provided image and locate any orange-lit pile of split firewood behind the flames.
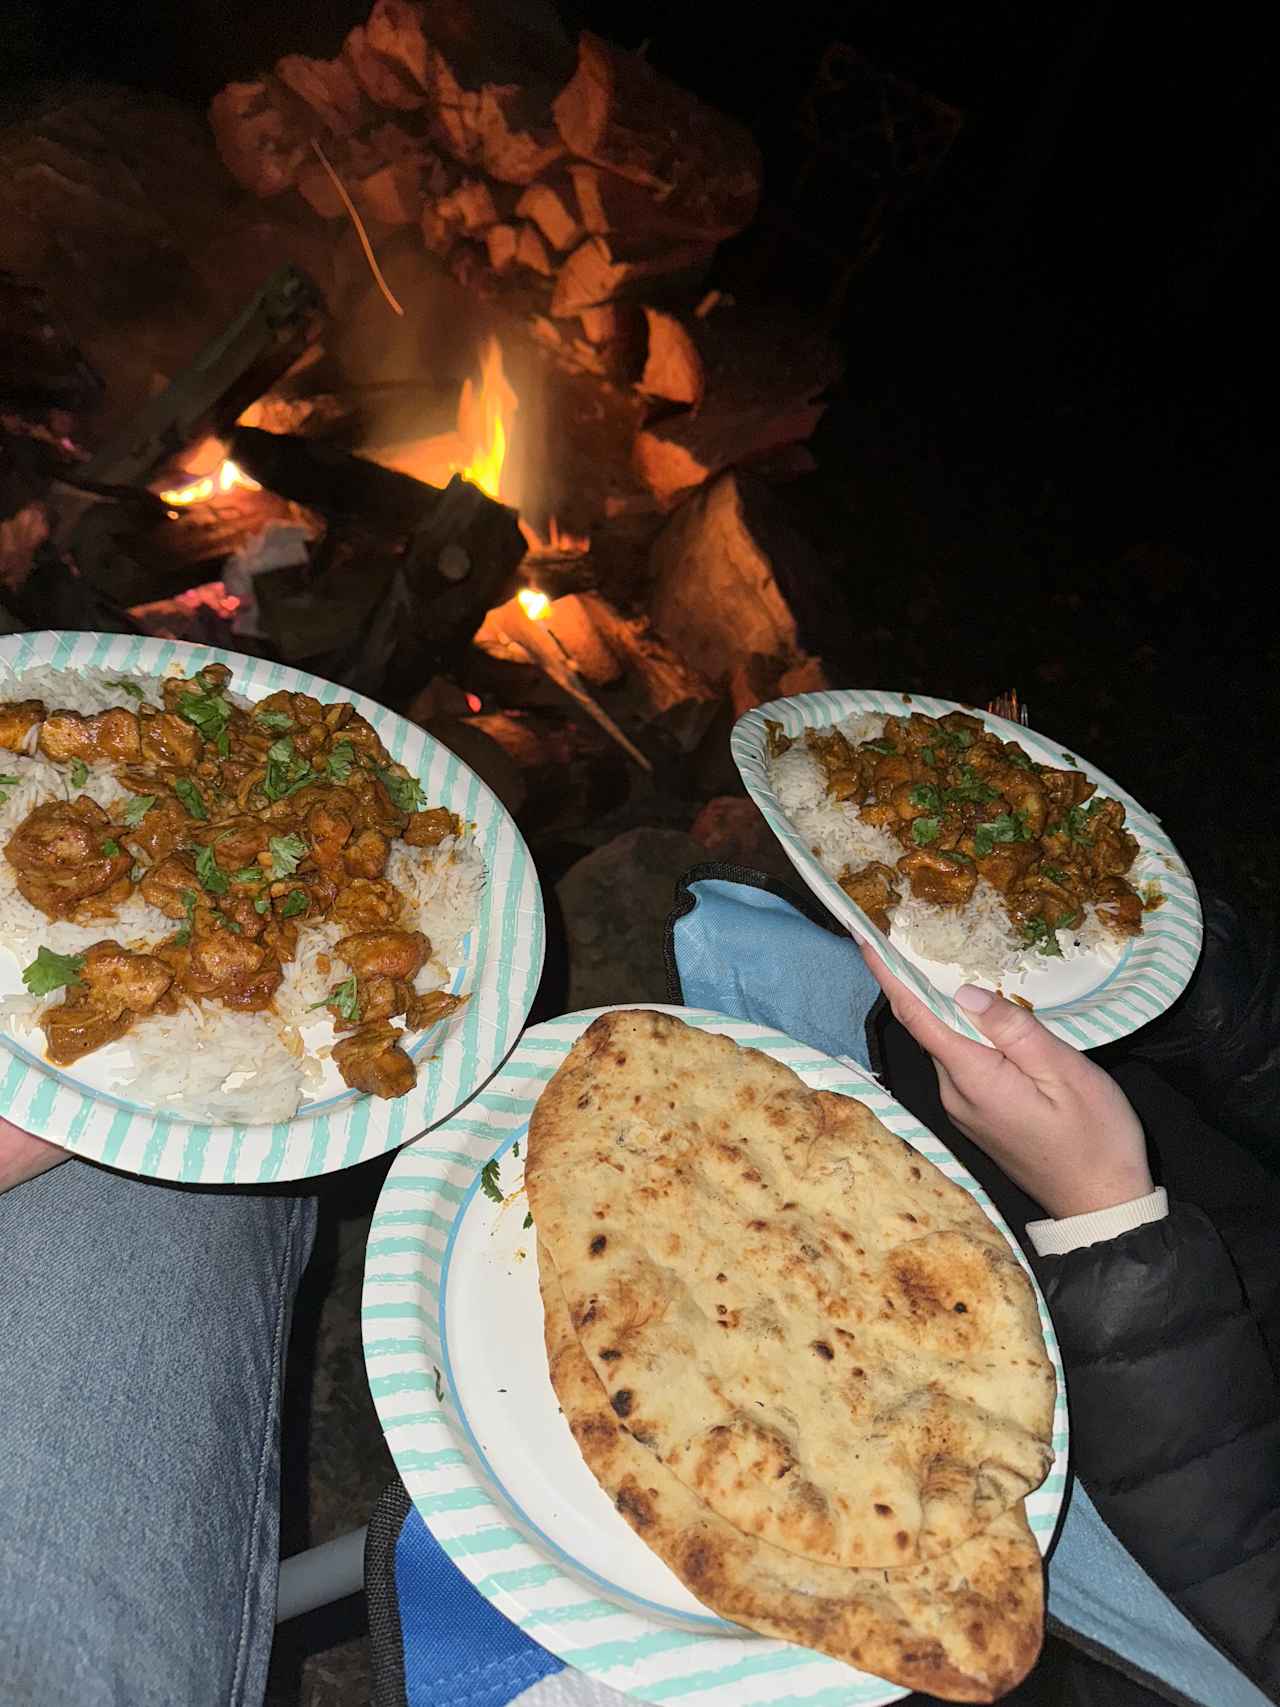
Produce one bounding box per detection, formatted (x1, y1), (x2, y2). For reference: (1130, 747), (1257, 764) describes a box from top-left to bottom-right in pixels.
(210, 0), (836, 504)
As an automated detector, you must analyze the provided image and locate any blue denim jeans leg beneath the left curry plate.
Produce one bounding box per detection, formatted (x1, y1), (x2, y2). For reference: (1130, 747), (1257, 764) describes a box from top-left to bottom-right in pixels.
(0, 1161), (316, 1707)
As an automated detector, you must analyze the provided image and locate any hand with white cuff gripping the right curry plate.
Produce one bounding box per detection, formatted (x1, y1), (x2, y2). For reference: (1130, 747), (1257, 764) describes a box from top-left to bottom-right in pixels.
(860, 942), (1152, 1221)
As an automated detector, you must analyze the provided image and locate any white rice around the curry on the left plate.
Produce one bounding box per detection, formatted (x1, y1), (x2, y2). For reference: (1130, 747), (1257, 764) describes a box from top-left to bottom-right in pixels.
(0, 666), (485, 1123)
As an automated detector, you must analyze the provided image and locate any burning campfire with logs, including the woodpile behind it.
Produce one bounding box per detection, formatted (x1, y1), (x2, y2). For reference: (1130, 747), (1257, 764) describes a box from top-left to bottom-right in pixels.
(5, 0), (840, 829)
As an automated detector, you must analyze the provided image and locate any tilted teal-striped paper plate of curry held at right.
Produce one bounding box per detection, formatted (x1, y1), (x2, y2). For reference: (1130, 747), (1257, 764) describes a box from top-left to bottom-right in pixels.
(729, 690), (1203, 1050)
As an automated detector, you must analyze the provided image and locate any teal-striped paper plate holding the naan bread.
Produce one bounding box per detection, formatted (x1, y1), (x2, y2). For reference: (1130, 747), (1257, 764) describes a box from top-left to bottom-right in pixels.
(364, 1004), (1067, 1707)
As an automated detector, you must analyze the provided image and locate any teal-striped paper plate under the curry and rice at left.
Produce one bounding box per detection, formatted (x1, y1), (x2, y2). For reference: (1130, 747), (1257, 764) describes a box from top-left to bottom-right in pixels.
(0, 633), (543, 1185)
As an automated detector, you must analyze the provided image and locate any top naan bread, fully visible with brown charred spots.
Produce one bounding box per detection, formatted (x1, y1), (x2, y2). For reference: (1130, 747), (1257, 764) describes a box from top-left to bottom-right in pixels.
(526, 1011), (1055, 1567)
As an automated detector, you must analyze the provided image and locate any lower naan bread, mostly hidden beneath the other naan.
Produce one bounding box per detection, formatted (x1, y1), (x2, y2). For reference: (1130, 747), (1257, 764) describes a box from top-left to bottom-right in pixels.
(538, 1244), (1044, 1702)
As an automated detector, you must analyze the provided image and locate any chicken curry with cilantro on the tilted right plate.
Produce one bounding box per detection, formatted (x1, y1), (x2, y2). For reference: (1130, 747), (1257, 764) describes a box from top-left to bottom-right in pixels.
(770, 712), (1143, 956)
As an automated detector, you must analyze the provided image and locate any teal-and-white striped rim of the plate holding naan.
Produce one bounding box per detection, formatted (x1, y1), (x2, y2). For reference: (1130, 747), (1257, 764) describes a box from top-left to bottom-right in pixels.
(362, 1002), (1068, 1707)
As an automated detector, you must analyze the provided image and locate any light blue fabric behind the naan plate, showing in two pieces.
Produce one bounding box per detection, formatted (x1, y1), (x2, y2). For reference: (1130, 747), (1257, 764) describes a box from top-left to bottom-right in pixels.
(674, 877), (1266, 1707)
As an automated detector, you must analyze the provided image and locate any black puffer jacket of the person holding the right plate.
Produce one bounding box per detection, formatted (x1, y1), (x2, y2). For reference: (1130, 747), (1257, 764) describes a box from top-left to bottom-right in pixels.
(874, 1017), (1280, 1707)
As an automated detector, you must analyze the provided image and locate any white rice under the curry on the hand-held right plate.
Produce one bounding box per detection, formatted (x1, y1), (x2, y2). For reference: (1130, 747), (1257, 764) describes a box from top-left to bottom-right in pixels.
(768, 712), (1123, 980)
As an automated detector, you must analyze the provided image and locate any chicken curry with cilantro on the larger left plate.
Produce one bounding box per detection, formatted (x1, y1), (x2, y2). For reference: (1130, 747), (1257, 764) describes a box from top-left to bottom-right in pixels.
(0, 664), (464, 1098)
